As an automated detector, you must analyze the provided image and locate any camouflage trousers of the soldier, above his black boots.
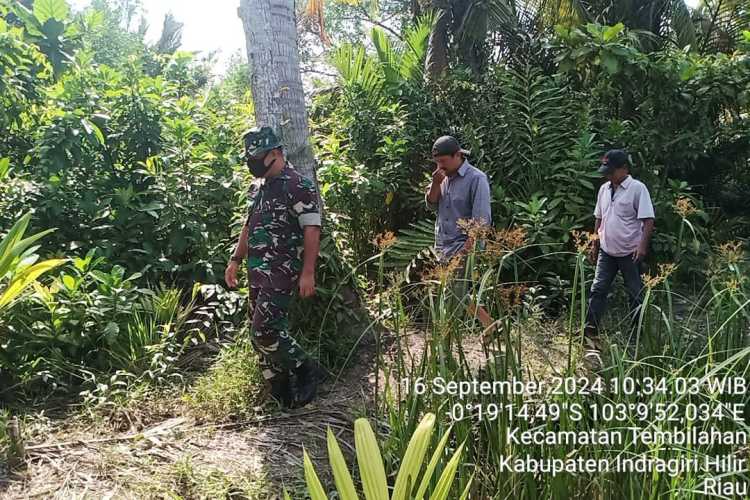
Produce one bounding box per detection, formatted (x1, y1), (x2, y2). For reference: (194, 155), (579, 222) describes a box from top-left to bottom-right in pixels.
(247, 287), (306, 380)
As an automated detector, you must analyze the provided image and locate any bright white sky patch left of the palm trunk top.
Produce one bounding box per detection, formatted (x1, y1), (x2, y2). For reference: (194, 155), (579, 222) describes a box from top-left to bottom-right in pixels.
(69, 0), (245, 70)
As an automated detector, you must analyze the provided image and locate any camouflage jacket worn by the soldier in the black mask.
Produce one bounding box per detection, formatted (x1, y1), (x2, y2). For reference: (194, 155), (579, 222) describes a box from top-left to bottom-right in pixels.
(247, 162), (320, 290)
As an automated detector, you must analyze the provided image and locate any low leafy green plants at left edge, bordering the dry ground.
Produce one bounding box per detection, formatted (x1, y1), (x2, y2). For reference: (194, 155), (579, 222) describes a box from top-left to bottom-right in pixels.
(5, 251), (204, 396)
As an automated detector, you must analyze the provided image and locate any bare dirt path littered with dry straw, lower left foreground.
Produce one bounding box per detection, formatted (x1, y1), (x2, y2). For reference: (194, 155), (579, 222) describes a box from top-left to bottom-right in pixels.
(0, 342), (374, 500)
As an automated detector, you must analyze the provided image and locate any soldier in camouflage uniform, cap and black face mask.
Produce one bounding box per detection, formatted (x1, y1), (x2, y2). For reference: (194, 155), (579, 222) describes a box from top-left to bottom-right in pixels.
(226, 127), (322, 407)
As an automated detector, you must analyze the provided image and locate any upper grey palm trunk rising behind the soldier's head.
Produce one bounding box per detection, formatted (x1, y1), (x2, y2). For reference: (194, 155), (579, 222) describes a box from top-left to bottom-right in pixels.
(238, 0), (317, 184)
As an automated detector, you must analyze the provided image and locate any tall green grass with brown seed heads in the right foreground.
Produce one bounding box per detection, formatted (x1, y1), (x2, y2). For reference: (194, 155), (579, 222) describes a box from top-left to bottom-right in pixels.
(362, 236), (750, 499)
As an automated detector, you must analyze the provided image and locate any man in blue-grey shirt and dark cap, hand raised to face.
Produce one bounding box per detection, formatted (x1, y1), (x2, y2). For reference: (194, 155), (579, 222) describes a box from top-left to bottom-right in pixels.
(425, 135), (493, 328)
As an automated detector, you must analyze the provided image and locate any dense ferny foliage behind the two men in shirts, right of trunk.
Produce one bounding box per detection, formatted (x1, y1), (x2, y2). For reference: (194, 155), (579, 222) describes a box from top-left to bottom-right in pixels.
(313, 19), (750, 286)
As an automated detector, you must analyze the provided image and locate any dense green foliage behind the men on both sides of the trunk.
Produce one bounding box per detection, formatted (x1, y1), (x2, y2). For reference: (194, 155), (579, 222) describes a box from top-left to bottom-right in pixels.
(0, 0), (750, 406)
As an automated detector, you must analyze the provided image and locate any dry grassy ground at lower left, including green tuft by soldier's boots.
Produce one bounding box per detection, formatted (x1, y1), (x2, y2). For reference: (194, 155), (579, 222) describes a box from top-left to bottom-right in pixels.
(0, 334), (372, 499)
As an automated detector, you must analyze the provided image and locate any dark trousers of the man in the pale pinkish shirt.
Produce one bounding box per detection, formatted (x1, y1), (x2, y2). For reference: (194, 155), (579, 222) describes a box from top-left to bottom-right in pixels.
(586, 250), (643, 331)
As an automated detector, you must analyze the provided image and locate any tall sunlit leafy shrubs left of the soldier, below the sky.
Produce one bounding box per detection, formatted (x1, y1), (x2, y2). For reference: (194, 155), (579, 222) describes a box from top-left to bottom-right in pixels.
(0, 0), (252, 288)
